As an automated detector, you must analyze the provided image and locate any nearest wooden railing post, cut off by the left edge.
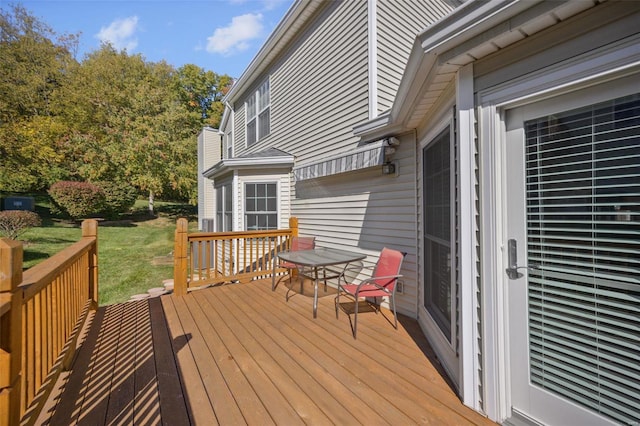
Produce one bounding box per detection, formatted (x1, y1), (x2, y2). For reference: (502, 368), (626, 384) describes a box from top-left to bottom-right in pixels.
(0, 238), (23, 426)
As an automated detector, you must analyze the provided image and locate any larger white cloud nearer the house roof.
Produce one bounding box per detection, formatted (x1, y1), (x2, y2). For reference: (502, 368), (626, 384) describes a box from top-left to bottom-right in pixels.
(207, 13), (263, 55)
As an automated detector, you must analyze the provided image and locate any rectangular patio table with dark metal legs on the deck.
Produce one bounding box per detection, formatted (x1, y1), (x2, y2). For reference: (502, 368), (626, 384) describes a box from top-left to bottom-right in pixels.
(271, 247), (367, 318)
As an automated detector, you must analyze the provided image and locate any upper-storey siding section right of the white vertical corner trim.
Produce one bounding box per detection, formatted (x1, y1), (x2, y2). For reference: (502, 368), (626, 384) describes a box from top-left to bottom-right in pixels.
(376, 0), (453, 112)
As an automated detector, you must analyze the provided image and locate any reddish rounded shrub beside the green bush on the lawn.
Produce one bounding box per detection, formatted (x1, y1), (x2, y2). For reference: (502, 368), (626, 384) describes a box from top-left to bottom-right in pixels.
(49, 181), (105, 219)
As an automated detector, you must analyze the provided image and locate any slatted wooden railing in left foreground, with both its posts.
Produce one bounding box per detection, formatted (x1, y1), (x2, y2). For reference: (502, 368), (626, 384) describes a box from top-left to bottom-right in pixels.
(0, 220), (98, 426)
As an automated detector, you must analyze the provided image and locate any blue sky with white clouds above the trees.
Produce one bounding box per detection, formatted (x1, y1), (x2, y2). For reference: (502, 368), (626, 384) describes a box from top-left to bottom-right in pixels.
(15, 0), (293, 77)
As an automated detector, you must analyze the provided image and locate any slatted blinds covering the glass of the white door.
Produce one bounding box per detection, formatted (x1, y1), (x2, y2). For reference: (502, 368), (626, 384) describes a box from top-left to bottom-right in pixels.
(525, 94), (640, 424)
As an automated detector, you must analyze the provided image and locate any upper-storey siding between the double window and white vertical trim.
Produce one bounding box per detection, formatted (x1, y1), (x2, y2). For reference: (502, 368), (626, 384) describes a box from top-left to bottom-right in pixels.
(268, 1), (368, 164)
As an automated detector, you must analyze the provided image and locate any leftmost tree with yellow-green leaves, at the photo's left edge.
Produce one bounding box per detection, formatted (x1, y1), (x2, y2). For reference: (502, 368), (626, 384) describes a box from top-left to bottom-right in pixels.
(0, 6), (77, 191)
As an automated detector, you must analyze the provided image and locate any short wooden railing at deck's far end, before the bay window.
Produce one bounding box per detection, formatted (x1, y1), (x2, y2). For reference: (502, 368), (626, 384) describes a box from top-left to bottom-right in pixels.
(173, 217), (298, 296)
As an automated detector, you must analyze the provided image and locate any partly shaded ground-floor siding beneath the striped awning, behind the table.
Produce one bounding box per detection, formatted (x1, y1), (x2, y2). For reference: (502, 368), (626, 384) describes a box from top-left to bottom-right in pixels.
(293, 134), (417, 316)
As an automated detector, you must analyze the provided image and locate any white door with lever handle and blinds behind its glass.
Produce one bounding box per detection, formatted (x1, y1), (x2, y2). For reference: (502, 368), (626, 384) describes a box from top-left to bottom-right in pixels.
(504, 90), (640, 426)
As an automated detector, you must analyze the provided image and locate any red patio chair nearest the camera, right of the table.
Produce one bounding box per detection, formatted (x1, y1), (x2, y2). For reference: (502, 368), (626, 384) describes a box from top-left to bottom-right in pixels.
(335, 247), (406, 339)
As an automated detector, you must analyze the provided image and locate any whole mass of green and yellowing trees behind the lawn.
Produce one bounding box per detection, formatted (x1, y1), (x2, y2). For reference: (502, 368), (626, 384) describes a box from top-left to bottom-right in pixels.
(0, 6), (232, 202)
